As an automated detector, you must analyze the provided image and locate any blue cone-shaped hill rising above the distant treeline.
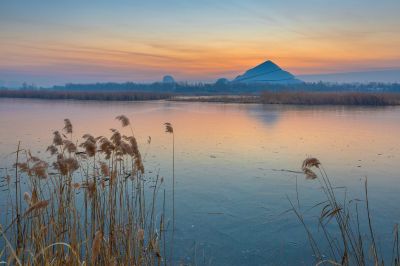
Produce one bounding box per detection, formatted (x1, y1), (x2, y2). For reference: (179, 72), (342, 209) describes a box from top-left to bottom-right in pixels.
(232, 60), (302, 84)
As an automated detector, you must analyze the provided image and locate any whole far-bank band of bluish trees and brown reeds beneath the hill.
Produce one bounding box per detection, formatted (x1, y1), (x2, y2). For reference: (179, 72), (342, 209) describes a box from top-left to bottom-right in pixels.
(0, 82), (400, 106)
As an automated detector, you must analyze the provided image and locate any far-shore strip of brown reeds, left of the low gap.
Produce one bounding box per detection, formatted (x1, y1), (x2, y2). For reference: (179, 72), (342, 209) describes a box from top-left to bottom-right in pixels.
(0, 90), (171, 101)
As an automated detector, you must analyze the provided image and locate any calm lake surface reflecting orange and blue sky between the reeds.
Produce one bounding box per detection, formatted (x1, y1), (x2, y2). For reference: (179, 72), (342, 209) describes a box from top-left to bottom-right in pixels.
(0, 99), (400, 265)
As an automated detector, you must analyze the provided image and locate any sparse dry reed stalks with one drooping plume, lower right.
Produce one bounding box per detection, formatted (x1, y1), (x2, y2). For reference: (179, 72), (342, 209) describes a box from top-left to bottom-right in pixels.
(296, 158), (399, 266)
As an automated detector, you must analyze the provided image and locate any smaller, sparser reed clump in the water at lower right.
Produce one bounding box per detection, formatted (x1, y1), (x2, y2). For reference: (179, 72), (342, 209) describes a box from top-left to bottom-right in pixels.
(289, 158), (400, 266)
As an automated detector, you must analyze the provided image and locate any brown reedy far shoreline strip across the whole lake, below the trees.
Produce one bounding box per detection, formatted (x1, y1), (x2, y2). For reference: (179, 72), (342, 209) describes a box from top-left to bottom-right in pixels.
(0, 90), (400, 106)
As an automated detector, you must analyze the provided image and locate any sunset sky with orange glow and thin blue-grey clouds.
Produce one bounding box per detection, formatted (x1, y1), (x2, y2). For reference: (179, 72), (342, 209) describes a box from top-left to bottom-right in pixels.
(0, 0), (400, 86)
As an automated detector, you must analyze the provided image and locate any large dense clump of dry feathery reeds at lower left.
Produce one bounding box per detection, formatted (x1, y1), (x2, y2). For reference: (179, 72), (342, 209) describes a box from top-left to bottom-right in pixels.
(0, 116), (166, 265)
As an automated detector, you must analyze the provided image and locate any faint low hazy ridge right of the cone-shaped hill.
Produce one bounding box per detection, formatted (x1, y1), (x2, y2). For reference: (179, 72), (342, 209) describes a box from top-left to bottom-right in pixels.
(299, 69), (400, 83)
